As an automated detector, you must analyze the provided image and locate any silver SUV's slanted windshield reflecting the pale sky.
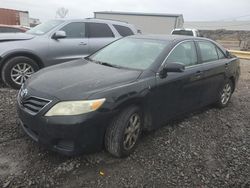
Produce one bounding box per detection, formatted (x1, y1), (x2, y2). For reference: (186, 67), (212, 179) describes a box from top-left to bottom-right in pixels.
(26, 20), (63, 35)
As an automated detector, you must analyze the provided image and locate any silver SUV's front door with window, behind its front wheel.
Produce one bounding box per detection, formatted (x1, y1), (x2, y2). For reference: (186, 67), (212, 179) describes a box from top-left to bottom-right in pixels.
(49, 22), (89, 64)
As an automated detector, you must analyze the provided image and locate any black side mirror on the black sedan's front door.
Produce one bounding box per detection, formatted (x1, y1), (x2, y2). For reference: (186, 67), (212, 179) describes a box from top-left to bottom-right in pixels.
(159, 62), (185, 78)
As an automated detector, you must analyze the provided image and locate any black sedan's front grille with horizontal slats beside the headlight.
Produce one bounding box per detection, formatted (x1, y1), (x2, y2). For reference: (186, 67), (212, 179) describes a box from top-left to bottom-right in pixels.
(20, 96), (50, 114)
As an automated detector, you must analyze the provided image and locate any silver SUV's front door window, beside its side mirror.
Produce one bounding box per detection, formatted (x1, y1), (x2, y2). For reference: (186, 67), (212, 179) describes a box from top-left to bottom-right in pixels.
(60, 22), (85, 38)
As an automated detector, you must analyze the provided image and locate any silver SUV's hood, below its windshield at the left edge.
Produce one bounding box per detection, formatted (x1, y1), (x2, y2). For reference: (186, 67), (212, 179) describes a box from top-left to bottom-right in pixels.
(0, 33), (35, 42)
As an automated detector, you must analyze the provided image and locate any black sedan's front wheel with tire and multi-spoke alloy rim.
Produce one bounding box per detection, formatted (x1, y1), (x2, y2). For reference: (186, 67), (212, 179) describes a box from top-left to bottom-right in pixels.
(105, 106), (143, 157)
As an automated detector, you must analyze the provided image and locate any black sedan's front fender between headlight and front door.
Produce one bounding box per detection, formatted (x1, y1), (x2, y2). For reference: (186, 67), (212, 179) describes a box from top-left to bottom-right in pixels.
(90, 77), (156, 130)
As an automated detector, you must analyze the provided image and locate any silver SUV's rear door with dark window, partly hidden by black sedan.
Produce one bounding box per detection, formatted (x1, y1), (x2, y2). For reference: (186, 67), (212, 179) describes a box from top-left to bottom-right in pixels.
(87, 22), (115, 54)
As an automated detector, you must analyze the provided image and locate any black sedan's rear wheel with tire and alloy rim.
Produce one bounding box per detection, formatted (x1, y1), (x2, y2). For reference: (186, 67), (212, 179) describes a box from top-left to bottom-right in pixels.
(216, 80), (233, 108)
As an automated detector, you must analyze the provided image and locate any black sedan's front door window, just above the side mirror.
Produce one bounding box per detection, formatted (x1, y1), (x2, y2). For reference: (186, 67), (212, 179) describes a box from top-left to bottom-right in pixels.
(167, 41), (198, 67)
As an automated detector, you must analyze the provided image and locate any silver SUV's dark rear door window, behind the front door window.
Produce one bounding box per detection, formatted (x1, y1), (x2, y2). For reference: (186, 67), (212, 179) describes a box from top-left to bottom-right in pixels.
(88, 23), (114, 38)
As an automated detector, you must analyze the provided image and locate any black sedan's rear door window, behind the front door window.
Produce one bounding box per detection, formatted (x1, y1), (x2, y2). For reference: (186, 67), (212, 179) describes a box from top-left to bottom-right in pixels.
(198, 41), (218, 62)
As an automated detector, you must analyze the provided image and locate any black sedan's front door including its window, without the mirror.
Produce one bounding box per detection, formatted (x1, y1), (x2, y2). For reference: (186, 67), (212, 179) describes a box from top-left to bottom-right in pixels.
(152, 40), (203, 125)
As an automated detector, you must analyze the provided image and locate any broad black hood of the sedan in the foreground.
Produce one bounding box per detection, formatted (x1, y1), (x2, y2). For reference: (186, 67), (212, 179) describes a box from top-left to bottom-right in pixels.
(27, 59), (142, 100)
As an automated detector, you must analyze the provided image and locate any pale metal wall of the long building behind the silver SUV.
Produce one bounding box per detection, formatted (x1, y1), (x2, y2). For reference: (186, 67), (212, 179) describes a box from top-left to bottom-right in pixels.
(95, 13), (183, 34)
